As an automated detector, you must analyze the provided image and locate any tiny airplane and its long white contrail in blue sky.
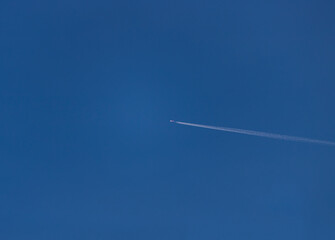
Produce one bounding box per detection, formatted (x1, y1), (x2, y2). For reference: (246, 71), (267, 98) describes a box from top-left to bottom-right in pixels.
(170, 120), (335, 146)
